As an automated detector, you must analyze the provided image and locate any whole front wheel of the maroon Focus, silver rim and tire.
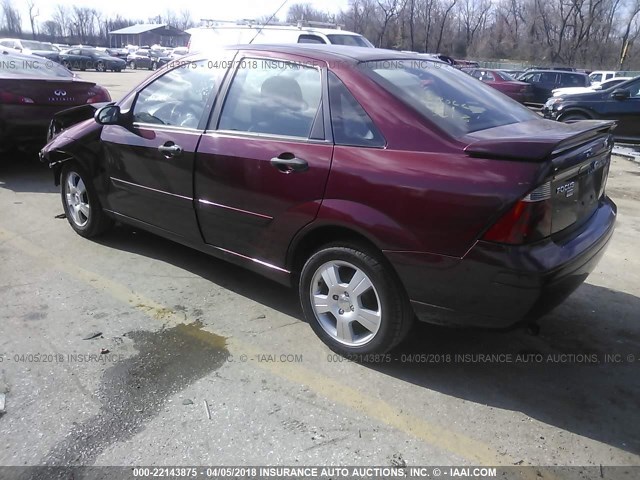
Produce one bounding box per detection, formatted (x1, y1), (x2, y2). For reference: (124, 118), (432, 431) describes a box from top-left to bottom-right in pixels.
(60, 162), (113, 238)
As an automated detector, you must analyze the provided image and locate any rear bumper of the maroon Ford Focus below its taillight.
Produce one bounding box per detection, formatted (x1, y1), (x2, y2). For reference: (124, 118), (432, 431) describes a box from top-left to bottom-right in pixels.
(385, 197), (616, 328)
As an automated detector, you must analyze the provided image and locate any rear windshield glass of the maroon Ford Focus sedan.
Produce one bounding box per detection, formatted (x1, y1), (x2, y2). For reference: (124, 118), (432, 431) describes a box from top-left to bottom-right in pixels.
(361, 59), (539, 136)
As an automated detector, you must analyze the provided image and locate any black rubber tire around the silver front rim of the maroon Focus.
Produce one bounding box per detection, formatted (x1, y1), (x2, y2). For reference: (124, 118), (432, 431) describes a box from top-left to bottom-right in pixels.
(60, 161), (113, 238)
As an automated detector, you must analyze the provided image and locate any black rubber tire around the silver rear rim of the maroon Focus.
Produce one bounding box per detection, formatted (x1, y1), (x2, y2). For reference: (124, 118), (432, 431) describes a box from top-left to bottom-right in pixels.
(298, 242), (415, 356)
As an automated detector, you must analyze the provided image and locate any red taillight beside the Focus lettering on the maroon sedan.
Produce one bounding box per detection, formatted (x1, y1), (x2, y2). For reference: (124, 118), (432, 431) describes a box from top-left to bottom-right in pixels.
(482, 182), (552, 245)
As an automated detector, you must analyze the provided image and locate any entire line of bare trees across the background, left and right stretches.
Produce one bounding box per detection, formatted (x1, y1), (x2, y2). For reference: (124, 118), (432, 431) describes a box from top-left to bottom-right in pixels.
(0, 0), (640, 70)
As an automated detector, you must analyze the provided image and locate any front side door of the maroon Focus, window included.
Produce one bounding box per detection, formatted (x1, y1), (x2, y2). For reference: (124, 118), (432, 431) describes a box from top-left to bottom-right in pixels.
(101, 61), (229, 241)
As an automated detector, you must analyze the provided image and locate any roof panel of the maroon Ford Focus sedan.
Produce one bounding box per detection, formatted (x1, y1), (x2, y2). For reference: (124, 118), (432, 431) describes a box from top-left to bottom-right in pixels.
(218, 43), (448, 65)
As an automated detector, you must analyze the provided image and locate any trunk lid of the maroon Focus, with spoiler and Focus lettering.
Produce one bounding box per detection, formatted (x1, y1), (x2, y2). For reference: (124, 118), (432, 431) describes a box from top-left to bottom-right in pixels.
(465, 120), (615, 235)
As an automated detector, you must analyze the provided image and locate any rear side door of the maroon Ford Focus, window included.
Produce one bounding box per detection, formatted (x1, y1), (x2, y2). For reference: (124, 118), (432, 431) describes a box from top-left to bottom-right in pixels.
(195, 52), (333, 264)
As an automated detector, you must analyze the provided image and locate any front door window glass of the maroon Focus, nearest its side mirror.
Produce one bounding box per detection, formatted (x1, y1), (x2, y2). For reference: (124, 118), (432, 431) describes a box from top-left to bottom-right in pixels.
(133, 60), (226, 128)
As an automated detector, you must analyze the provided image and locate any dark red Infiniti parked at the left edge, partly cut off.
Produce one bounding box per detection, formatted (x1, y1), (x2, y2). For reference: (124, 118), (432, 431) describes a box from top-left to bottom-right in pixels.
(0, 46), (111, 151)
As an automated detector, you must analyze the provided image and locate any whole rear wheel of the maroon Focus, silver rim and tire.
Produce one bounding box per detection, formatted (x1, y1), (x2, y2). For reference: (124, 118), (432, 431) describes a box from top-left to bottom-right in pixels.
(299, 243), (414, 355)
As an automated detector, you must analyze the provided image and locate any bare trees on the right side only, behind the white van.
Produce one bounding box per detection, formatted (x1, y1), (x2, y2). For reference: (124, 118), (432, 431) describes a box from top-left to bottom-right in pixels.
(288, 0), (640, 70)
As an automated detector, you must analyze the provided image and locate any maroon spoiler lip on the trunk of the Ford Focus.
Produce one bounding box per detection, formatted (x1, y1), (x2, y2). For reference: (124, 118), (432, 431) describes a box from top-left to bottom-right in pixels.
(464, 120), (616, 161)
